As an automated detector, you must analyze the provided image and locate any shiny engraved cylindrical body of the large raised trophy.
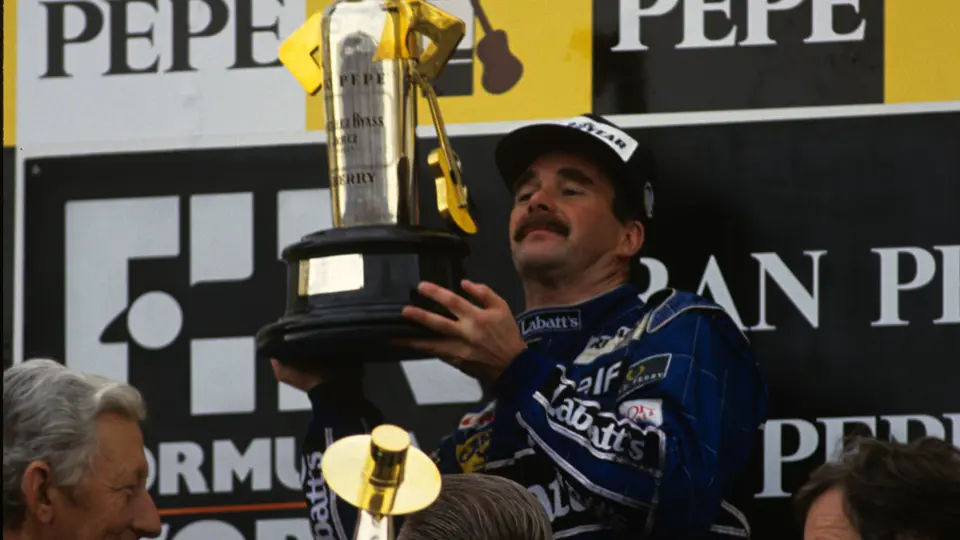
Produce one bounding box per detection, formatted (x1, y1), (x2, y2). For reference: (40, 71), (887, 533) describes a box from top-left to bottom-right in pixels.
(323, 3), (417, 227)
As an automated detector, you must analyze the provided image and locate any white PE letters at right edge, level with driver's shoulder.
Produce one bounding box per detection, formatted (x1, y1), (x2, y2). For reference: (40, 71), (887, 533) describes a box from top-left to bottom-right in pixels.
(870, 245), (960, 326)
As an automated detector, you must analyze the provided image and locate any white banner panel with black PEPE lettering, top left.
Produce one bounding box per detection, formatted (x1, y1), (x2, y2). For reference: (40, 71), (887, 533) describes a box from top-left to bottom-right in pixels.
(17, 0), (306, 145)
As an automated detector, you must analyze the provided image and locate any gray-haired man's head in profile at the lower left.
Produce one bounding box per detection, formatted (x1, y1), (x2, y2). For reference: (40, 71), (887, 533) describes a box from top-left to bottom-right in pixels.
(3, 359), (161, 540)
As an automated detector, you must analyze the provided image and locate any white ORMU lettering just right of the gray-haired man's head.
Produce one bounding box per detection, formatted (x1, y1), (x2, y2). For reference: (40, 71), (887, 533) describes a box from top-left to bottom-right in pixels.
(144, 437), (301, 497)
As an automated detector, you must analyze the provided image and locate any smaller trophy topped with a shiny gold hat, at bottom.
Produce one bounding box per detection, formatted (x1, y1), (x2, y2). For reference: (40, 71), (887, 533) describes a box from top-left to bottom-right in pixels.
(320, 424), (441, 540)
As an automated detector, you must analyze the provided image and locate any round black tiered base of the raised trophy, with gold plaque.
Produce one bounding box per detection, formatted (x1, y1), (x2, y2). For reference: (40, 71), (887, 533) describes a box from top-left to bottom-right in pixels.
(257, 225), (470, 367)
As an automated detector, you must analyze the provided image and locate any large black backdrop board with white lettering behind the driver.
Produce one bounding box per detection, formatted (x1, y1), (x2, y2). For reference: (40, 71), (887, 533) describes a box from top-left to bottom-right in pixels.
(18, 113), (960, 540)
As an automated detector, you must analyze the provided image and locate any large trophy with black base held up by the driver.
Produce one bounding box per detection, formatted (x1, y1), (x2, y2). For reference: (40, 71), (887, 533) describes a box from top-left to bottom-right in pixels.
(257, 0), (476, 364)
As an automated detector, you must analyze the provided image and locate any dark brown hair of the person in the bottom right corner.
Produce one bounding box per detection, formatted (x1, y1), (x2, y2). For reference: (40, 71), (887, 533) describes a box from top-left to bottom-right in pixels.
(794, 437), (960, 540)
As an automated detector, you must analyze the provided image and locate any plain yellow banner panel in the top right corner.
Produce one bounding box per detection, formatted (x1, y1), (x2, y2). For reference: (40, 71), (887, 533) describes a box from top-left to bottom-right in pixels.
(884, 0), (960, 103)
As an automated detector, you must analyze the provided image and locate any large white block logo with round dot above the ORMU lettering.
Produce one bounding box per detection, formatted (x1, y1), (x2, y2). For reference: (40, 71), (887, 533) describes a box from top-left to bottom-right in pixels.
(56, 189), (478, 416)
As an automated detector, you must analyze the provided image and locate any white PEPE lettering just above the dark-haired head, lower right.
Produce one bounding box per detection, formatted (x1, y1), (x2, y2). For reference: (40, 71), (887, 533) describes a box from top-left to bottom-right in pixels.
(755, 413), (960, 499)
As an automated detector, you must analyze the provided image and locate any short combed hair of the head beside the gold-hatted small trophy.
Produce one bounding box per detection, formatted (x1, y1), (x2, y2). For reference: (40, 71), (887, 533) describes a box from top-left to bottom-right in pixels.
(397, 473), (553, 540)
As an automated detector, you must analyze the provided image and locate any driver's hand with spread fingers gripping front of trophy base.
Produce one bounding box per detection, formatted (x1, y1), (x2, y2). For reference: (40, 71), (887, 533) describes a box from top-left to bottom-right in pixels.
(398, 279), (527, 380)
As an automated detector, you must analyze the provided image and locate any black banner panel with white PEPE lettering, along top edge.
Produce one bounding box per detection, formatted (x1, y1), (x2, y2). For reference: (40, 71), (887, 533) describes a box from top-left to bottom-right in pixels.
(593, 0), (884, 114)
